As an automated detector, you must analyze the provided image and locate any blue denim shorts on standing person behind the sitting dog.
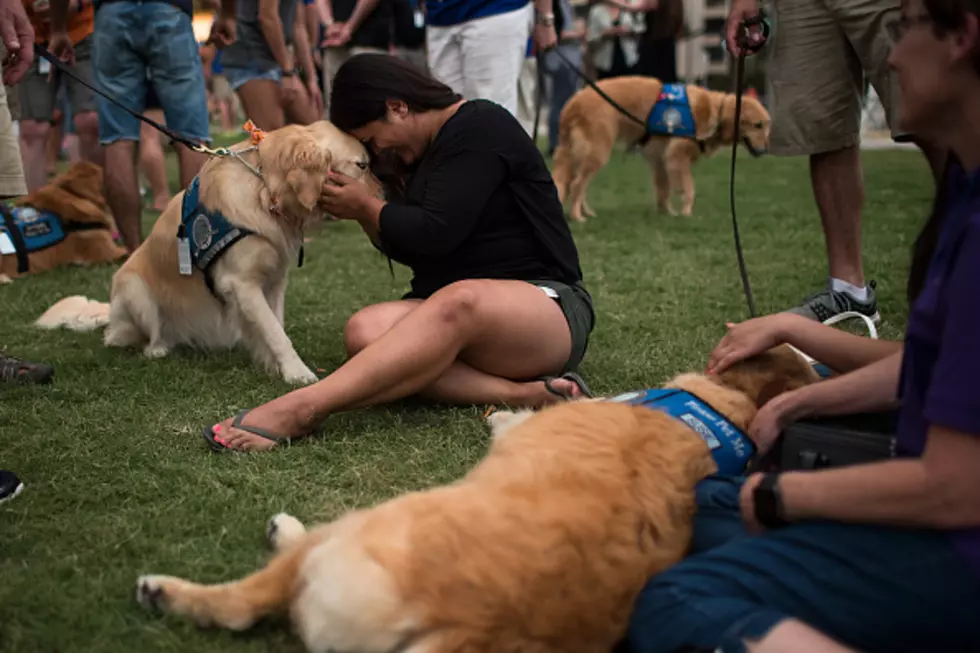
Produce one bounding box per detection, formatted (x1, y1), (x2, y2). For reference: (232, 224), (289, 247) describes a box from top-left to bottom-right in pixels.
(92, 0), (211, 145)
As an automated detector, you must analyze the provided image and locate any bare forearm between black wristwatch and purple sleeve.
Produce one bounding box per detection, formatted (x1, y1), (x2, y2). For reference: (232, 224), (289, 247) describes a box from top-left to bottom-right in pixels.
(779, 426), (980, 529)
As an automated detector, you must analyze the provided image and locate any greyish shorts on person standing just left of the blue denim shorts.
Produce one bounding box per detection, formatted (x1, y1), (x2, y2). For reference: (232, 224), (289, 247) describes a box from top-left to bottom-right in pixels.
(19, 36), (96, 122)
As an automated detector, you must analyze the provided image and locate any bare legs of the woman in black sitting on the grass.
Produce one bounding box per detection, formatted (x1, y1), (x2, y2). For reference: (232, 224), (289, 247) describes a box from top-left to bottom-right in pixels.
(213, 280), (588, 450)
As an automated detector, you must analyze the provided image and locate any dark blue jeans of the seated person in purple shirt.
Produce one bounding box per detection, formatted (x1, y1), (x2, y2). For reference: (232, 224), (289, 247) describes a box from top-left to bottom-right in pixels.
(617, 476), (980, 653)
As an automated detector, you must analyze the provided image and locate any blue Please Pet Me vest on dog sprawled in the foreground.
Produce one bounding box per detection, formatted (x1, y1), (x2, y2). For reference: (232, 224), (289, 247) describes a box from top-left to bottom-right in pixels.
(609, 388), (756, 475)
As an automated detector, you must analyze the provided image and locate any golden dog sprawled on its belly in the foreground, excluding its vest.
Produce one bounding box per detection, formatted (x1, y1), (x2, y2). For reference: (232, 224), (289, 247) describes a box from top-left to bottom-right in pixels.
(136, 347), (817, 653)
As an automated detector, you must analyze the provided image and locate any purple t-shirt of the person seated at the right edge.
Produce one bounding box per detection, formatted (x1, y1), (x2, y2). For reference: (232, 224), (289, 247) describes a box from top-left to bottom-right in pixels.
(896, 158), (980, 576)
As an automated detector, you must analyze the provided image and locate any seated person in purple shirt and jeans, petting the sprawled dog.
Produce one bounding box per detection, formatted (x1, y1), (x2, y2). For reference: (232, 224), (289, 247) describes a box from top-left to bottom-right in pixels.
(619, 0), (980, 653)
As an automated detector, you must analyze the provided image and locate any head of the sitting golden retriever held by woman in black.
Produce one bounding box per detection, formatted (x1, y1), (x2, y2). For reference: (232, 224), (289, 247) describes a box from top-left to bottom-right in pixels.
(259, 120), (383, 219)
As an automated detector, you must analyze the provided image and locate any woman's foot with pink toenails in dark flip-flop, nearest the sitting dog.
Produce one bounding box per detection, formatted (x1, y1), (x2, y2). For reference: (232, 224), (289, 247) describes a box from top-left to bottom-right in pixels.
(211, 397), (314, 451)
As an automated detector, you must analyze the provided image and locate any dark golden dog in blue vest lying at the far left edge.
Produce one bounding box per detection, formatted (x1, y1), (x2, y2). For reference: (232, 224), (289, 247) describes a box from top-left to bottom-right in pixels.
(0, 161), (126, 280)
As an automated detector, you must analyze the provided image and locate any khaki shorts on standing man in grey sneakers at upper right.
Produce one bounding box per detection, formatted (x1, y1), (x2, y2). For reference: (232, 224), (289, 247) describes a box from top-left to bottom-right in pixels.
(766, 0), (909, 155)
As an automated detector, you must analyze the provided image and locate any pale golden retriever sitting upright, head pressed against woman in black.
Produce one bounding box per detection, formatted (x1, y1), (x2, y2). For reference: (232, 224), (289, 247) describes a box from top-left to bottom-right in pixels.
(36, 121), (382, 383)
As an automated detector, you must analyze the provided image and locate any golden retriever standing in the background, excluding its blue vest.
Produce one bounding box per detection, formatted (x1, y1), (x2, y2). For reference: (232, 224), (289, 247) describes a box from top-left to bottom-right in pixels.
(552, 76), (770, 222)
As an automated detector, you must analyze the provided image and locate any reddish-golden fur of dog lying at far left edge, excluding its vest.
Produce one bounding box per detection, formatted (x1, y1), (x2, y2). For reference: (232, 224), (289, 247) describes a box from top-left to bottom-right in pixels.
(0, 161), (126, 278)
